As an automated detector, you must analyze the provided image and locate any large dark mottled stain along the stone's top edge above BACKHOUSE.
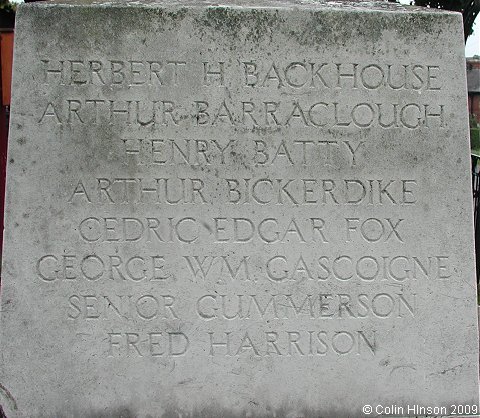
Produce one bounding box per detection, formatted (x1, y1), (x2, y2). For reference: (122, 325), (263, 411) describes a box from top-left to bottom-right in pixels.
(189, 6), (448, 47)
